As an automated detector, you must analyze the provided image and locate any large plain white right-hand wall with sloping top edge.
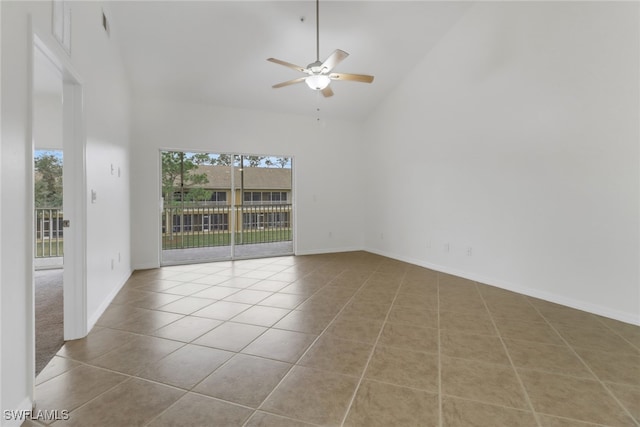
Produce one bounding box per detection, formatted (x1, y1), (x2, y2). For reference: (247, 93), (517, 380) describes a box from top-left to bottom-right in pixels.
(365, 2), (640, 324)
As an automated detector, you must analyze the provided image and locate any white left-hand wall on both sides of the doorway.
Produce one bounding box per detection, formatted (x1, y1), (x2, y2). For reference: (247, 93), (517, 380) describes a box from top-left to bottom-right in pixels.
(0, 1), (130, 425)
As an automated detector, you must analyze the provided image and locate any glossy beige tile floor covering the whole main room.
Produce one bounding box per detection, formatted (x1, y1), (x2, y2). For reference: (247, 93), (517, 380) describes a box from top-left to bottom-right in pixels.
(23, 252), (640, 427)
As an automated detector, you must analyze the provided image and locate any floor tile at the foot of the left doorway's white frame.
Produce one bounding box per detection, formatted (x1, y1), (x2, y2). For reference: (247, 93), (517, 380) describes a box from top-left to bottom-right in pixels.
(58, 327), (137, 362)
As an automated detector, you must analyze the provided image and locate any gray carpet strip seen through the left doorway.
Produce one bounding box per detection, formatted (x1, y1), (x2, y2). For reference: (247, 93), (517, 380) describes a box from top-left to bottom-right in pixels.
(35, 269), (64, 375)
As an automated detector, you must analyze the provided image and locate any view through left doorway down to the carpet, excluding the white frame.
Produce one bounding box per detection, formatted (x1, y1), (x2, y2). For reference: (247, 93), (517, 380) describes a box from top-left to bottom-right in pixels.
(32, 44), (64, 376)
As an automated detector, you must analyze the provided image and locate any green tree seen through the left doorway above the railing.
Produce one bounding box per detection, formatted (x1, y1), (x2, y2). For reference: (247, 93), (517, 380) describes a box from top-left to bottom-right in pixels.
(34, 153), (62, 208)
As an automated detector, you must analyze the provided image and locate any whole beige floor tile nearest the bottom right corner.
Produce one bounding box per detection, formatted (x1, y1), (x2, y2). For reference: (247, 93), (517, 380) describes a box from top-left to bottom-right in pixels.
(518, 369), (633, 426)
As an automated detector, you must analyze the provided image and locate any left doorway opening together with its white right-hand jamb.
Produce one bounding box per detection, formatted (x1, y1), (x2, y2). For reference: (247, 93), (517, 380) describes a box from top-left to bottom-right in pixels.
(27, 28), (87, 388)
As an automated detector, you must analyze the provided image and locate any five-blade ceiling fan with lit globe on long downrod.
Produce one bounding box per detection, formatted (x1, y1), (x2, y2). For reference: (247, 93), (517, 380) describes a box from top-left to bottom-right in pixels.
(267, 0), (373, 97)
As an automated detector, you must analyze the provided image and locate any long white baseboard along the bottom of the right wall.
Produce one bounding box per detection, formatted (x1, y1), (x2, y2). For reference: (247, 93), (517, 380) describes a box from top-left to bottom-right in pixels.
(364, 248), (640, 326)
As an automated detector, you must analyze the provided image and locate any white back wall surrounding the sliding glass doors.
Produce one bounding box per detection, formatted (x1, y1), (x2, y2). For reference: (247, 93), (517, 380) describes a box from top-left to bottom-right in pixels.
(131, 99), (363, 268)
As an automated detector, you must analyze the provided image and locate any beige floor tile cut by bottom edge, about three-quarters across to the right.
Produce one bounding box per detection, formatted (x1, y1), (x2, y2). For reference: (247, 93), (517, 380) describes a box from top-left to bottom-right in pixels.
(442, 397), (538, 427)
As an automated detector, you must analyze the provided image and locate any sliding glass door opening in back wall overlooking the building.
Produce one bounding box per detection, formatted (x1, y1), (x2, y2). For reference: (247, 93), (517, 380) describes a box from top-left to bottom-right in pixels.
(160, 151), (294, 265)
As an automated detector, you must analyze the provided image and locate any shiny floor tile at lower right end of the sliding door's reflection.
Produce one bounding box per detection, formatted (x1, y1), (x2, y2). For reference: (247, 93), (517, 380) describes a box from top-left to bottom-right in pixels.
(242, 329), (316, 363)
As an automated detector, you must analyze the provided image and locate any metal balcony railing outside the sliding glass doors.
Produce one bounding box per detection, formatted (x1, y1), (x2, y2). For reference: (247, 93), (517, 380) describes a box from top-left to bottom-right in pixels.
(162, 204), (292, 250)
